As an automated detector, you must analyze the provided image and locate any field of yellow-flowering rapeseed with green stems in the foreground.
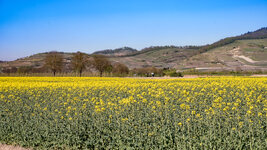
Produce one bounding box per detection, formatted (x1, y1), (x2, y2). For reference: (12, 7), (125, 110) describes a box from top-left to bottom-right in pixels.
(0, 77), (267, 149)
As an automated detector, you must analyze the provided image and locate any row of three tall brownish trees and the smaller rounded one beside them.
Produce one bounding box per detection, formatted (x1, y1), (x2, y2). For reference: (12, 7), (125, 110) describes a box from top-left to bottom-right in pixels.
(45, 52), (129, 77)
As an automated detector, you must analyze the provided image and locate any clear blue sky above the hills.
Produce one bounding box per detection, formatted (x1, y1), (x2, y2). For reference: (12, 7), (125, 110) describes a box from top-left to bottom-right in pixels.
(0, 0), (267, 60)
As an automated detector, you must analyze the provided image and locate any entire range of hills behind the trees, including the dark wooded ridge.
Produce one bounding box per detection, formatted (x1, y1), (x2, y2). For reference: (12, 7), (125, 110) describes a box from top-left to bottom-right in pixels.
(0, 27), (267, 70)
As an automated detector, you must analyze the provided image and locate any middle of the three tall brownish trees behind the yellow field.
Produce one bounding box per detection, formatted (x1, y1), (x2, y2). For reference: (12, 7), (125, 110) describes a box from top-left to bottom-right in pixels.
(71, 52), (88, 77)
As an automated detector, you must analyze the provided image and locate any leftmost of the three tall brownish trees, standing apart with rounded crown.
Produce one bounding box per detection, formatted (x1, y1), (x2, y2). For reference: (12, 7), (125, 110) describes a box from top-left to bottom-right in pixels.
(45, 52), (63, 76)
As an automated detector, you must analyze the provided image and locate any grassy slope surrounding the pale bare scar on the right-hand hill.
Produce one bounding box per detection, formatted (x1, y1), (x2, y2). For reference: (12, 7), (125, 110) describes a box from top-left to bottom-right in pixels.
(180, 39), (267, 68)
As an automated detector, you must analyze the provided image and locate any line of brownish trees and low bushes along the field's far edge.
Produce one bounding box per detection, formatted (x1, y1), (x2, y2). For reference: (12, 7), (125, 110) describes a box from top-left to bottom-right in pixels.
(0, 51), (183, 77)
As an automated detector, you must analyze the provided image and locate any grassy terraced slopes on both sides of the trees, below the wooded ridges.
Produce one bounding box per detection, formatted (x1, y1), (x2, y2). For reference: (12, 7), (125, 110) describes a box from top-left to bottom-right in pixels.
(0, 39), (267, 69)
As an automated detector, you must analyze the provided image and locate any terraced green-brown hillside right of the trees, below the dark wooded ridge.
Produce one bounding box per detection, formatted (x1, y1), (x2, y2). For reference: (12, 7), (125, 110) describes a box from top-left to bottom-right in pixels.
(107, 39), (267, 70)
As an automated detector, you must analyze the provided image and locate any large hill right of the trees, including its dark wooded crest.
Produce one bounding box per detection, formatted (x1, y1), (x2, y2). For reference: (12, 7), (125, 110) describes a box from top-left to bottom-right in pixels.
(107, 28), (267, 70)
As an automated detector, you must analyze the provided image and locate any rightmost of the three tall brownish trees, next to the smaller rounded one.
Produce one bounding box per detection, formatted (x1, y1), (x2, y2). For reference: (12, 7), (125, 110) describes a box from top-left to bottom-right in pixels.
(93, 55), (112, 77)
